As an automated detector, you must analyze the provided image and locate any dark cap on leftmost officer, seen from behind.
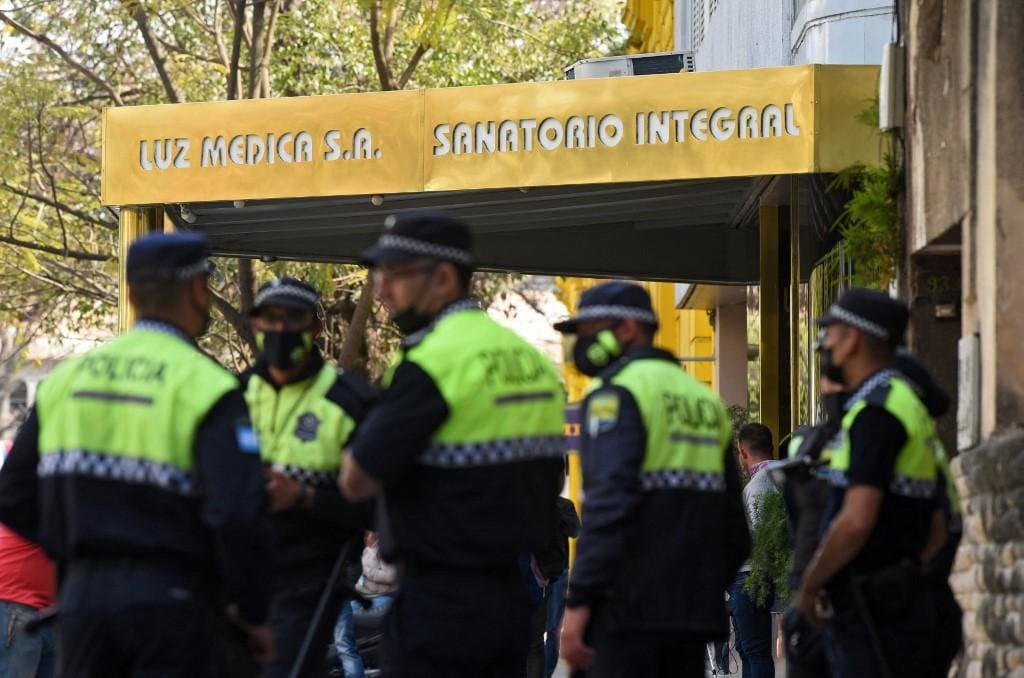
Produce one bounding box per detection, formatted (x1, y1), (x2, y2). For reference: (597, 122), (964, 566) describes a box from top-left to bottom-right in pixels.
(125, 232), (213, 283)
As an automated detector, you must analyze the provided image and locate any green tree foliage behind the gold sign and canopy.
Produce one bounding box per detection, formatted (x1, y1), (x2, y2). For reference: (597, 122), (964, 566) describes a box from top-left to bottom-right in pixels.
(0, 0), (623, 371)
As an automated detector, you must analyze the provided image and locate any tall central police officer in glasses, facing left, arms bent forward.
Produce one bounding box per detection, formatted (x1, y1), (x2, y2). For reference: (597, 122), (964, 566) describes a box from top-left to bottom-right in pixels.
(341, 212), (564, 678)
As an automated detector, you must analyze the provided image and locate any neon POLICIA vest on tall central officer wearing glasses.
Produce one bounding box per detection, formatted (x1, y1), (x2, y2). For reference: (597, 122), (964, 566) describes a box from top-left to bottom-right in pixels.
(401, 301), (565, 468)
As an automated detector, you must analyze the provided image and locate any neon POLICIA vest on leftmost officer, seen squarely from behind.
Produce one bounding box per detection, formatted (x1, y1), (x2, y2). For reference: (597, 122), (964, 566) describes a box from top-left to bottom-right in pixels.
(36, 323), (238, 495)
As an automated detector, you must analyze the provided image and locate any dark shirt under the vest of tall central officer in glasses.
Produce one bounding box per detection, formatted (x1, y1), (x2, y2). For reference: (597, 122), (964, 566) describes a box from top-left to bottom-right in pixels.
(351, 303), (563, 567)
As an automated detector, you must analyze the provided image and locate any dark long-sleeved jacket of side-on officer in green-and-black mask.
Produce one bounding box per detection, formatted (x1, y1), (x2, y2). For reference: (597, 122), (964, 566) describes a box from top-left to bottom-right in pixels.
(568, 348), (750, 634)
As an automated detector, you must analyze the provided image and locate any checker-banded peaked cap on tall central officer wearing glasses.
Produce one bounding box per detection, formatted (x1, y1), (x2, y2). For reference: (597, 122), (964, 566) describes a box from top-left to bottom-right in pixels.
(359, 210), (476, 270)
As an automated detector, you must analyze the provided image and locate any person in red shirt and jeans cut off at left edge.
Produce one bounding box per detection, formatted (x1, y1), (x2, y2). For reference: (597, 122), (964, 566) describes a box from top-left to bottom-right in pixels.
(0, 442), (56, 678)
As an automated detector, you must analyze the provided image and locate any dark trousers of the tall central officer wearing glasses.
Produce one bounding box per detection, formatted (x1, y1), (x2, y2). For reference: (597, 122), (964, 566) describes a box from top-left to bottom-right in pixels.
(384, 563), (530, 678)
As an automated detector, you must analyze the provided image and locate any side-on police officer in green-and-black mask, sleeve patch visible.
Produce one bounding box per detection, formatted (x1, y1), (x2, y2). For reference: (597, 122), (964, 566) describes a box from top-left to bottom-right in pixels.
(555, 282), (751, 678)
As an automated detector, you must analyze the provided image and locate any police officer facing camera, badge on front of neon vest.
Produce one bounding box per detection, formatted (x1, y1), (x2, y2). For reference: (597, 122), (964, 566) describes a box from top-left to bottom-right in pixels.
(242, 278), (375, 676)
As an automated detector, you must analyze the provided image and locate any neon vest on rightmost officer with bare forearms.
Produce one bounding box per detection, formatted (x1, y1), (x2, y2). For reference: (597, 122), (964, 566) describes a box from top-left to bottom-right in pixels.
(829, 370), (941, 499)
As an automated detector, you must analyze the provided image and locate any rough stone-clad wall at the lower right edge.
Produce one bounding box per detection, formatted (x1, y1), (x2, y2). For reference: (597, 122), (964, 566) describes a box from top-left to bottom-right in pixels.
(950, 427), (1024, 678)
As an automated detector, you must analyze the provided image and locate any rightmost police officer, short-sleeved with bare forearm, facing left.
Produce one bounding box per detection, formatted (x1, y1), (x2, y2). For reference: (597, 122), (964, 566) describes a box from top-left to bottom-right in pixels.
(797, 288), (938, 678)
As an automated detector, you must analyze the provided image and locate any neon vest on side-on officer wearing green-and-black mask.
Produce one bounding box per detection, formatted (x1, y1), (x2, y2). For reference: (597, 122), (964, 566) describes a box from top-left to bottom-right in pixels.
(593, 358), (732, 492)
